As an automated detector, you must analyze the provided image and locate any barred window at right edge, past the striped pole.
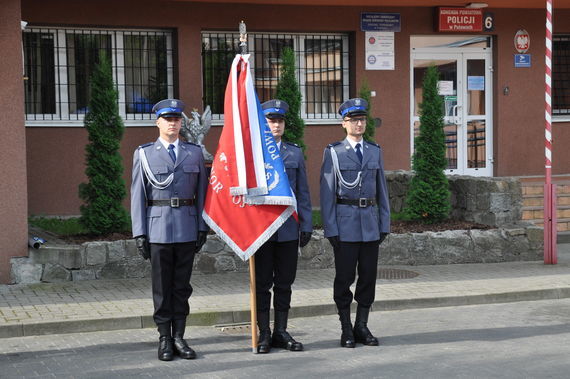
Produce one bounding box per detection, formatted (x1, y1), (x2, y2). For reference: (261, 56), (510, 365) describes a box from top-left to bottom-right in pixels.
(552, 35), (570, 117)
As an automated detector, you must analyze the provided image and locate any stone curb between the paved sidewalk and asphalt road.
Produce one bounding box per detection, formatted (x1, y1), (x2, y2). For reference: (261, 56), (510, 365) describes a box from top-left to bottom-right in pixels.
(4, 287), (570, 338)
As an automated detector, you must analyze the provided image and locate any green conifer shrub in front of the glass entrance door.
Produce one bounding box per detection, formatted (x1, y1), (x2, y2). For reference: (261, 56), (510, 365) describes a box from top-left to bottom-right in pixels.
(404, 66), (451, 223)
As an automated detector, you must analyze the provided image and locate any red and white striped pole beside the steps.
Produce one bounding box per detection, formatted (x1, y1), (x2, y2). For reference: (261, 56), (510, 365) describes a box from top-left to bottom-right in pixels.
(544, 0), (557, 264)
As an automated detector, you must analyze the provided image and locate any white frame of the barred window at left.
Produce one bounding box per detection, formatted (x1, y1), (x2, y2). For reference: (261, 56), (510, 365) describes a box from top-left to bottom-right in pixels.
(22, 25), (173, 127)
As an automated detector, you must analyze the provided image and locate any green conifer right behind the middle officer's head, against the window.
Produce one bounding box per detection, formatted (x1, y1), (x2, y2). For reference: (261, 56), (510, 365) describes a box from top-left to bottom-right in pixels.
(275, 47), (306, 151)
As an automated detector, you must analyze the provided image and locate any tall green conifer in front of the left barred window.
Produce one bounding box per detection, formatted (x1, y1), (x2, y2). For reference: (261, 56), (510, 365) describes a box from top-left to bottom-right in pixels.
(79, 54), (128, 235)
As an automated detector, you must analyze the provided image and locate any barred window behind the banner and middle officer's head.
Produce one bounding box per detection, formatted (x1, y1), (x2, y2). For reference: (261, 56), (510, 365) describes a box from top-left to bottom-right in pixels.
(202, 32), (350, 122)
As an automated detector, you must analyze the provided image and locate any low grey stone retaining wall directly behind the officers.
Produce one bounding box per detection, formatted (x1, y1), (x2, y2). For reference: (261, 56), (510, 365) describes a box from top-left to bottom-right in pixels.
(12, 225), (543, 283)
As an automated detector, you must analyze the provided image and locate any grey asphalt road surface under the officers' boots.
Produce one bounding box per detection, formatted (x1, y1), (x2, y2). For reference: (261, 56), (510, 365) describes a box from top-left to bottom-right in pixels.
(0, 299), (570, 379)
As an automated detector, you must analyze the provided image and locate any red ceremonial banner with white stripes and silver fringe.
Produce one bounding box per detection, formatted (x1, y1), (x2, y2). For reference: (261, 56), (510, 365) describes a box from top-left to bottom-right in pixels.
(203, 55), (295, 260)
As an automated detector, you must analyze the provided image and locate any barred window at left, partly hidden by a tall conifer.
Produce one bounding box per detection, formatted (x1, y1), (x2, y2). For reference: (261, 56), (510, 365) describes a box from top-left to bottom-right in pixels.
(22, 26), (175, 126)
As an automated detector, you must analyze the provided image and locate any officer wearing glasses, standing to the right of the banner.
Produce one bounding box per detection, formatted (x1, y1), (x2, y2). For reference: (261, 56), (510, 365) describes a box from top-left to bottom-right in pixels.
(320, 98), (390, 347)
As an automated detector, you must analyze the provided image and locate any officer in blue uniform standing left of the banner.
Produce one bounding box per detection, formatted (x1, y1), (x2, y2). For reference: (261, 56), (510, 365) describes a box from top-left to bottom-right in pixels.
(131, 99), (208, 361)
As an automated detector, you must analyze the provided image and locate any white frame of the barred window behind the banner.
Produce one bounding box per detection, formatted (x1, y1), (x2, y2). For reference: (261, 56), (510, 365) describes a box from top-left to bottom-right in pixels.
(200, 30), (351, 125)
